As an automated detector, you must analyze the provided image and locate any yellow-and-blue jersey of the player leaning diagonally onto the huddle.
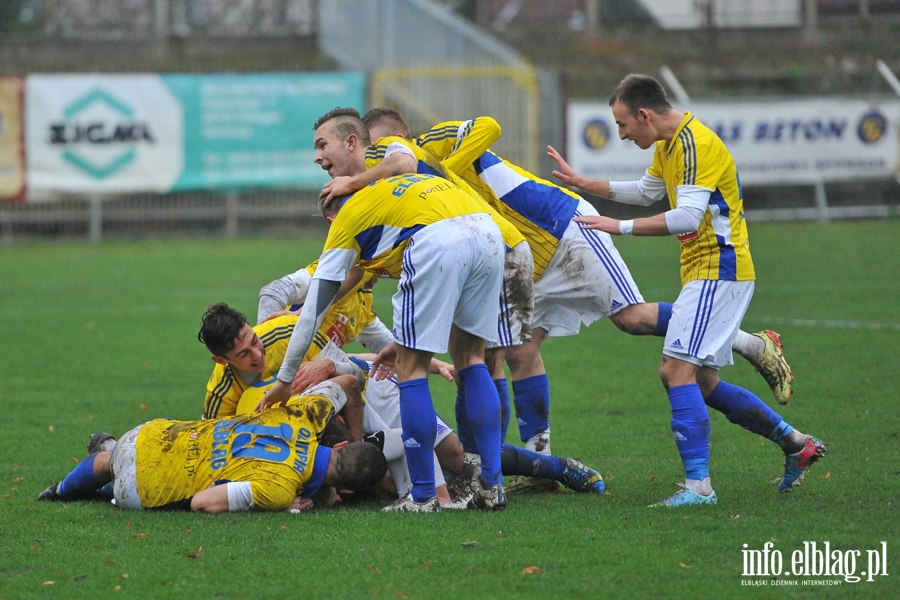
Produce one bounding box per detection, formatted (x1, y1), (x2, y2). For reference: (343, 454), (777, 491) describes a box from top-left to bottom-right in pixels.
(414, 117), (580, 280)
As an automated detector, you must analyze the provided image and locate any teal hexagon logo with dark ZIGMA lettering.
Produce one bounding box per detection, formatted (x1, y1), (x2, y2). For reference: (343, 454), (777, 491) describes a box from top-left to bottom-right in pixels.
(49, 88), (155, 179)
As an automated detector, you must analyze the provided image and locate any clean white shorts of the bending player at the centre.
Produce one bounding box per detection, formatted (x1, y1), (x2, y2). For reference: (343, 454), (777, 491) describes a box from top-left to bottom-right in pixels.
(393, 213), (506, 353)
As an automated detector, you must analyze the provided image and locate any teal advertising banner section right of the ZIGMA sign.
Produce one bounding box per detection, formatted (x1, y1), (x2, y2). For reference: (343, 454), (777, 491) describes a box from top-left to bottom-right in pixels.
(162, 73), (365, 190)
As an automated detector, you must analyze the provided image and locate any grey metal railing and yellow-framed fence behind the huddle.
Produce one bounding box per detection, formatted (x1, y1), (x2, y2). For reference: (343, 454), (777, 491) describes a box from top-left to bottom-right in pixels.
(319, 0), (540, 171)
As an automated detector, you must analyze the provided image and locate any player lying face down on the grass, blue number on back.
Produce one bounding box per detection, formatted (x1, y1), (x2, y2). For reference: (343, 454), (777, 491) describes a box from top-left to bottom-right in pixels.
(38, 382), (387, 513)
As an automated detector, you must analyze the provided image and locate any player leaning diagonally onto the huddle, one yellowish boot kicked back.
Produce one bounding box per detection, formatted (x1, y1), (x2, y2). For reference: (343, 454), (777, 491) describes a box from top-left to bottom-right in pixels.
(363, 108), (793, 490)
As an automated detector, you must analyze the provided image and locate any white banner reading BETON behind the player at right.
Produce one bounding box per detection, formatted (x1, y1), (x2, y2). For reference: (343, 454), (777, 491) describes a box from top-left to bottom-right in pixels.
(565, 98), (900, 185)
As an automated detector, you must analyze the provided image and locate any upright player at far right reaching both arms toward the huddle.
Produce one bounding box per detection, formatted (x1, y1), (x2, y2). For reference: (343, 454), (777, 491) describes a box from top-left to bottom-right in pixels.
(549, 74), (825, 506)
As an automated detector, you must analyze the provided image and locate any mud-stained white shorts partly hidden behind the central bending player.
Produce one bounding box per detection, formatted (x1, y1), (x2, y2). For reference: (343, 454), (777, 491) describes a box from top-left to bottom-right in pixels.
(486, 242), (534, 348)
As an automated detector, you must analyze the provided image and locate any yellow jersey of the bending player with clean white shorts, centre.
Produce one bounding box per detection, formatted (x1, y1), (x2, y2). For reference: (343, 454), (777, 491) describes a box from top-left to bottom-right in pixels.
(315, 173), (487, 281)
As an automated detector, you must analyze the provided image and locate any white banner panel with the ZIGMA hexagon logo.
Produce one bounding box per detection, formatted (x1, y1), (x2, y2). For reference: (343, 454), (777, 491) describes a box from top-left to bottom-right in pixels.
(25, 75), (184, 197)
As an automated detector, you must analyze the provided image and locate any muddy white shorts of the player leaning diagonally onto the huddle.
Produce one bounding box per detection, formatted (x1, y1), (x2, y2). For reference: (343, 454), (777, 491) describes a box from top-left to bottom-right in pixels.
(534, 200), (644, 336)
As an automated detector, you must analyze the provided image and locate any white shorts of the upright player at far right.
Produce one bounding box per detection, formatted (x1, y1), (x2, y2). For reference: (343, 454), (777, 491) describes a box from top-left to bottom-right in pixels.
(663, 280), (755, 369)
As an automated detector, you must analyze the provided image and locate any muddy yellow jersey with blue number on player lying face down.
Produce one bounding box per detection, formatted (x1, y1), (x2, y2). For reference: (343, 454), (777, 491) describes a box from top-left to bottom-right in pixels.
(135, 394), (335, 510)
